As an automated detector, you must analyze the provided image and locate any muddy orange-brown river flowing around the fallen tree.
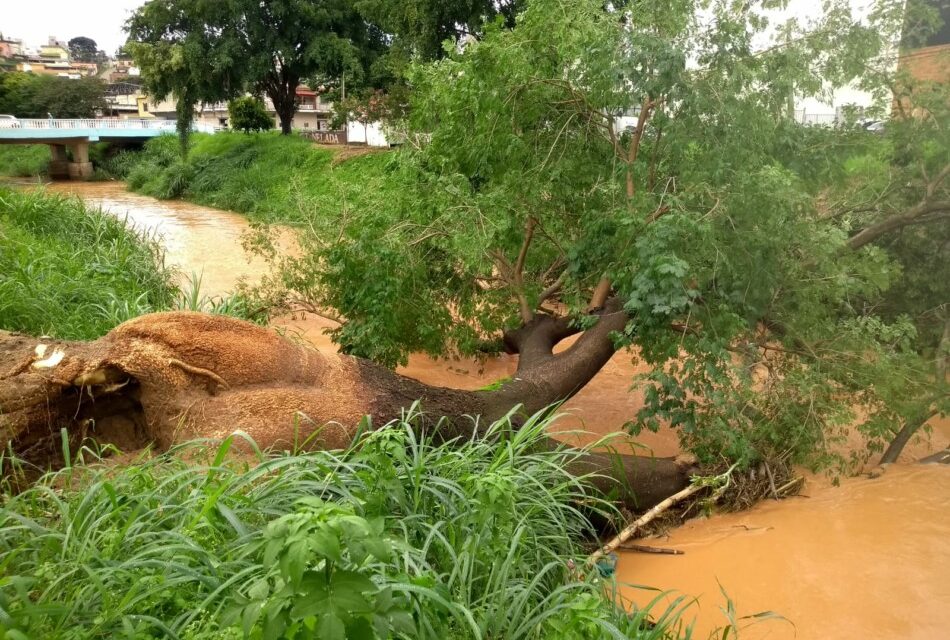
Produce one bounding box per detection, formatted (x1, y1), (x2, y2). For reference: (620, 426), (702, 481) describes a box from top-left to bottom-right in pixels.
(29, 182), (950, 640)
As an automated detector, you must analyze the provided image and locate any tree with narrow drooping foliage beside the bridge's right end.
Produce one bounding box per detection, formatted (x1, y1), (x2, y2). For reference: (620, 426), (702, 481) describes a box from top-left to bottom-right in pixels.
(124, 0), (246, 154)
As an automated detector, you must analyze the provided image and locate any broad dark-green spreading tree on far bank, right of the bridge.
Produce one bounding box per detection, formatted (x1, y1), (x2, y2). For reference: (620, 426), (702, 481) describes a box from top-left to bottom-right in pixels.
(128, 0), (385, 133)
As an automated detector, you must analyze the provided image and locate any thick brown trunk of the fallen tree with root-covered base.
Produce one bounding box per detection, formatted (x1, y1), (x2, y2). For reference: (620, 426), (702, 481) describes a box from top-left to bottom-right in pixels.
(0, 311), (690, 509)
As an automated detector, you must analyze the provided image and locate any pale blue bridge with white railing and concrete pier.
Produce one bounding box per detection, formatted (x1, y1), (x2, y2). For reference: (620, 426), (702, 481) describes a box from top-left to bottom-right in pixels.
(0, 118), (214, 180)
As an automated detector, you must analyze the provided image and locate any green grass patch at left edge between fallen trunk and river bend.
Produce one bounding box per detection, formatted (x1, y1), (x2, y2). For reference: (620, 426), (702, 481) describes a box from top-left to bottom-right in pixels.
(0, 186), (177, 339)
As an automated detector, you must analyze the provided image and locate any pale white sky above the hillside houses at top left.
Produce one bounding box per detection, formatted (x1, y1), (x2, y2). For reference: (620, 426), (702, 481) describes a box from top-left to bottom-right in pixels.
(0, 0), (145, 55)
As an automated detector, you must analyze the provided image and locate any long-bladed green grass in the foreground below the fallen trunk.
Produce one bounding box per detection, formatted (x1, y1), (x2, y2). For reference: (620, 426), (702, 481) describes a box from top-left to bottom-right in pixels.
(0, 414), (704, 640)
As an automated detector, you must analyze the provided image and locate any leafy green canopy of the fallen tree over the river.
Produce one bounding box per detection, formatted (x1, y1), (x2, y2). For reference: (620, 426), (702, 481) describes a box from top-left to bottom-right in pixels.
(274, 0), (950, 470)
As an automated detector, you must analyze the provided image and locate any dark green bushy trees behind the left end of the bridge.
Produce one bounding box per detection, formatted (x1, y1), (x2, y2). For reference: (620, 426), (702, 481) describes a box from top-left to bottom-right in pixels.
(0, 72), (106, 118)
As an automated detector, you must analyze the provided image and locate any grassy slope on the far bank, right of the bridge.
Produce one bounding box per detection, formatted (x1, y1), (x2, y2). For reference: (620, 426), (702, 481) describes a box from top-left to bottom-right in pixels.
(119, 132), (390, 224)
